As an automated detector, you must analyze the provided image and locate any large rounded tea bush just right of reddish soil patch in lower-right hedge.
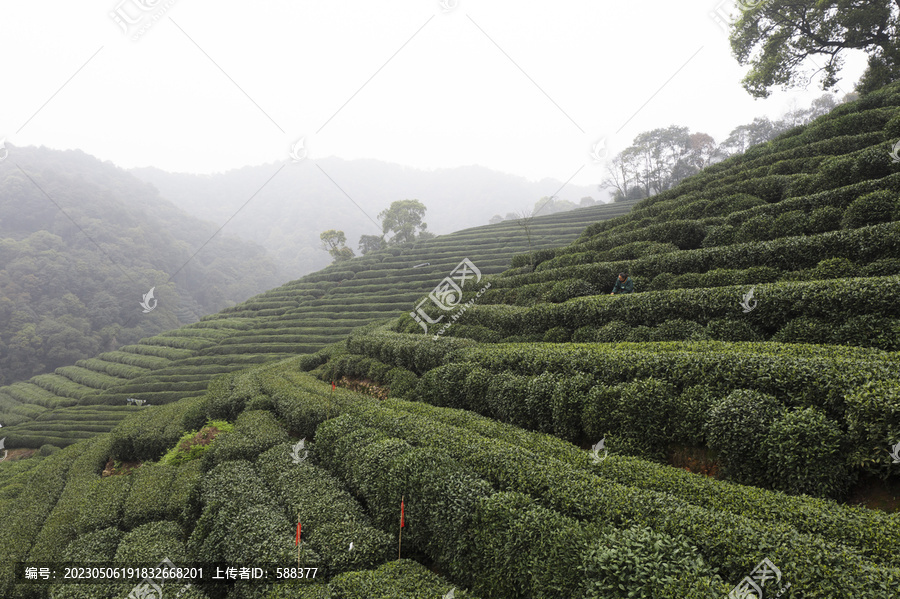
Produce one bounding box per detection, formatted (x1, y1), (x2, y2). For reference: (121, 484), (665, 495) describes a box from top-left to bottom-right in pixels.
(707, 389), (784, 487)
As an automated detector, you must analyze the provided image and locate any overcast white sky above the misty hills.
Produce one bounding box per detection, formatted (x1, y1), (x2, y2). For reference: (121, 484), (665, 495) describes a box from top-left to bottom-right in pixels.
(0, 0), (864, 185)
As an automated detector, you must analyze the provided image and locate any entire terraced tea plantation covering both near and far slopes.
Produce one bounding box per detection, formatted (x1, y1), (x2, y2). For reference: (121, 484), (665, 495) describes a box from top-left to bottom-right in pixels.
(0, 85), (900, 599)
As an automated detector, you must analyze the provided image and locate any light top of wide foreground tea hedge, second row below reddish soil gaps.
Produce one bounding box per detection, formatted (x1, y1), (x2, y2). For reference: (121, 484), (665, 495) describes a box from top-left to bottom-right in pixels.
(323, 396), (896, 599)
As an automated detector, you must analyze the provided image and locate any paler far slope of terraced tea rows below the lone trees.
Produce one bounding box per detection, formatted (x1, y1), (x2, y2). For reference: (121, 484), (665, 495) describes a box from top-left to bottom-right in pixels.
(0, 203), (633, 448)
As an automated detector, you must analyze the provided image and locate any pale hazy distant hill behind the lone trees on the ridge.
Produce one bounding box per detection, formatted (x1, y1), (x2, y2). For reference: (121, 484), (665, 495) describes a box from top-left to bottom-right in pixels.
(130, 158), (607, 278)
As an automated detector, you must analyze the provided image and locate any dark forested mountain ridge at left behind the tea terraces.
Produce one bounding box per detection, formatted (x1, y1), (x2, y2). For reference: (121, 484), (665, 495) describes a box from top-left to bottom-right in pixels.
(0, 147), (279, 384)
